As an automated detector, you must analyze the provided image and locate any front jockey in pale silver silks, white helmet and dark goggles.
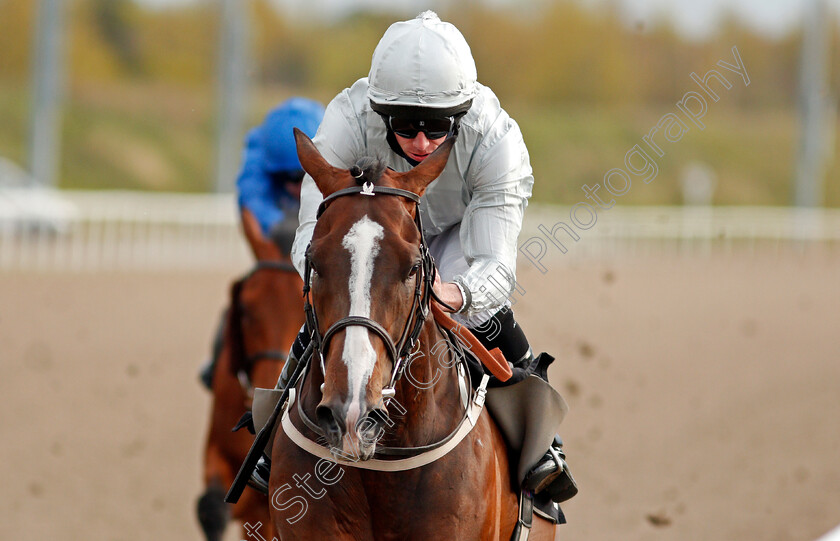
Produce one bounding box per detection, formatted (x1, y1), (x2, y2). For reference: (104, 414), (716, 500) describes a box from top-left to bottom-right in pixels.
(252, 11), (577, 510)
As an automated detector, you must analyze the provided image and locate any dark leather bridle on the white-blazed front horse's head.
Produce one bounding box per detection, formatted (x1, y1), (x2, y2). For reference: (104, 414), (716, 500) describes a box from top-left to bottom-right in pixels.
(303, 182), (450, 400)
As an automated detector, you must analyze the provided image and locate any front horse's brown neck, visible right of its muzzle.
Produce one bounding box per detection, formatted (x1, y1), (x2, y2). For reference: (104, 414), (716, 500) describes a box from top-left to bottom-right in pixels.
(389, 320), (463, 446)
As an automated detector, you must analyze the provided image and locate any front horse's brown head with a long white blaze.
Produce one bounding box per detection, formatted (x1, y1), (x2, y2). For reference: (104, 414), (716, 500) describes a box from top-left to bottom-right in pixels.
(296, 129), (454, 459)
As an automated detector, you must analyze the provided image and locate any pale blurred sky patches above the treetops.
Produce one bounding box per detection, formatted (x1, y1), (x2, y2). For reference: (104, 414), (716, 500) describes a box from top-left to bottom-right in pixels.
(138, 0), (840, 38)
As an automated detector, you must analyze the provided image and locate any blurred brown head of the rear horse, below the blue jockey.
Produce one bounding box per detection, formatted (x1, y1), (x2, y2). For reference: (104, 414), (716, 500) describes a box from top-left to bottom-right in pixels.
(228, 210), (303, 387)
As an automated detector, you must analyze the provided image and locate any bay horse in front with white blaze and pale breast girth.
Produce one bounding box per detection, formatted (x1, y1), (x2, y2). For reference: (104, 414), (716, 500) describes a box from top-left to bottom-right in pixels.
(269, 133), (555, 541)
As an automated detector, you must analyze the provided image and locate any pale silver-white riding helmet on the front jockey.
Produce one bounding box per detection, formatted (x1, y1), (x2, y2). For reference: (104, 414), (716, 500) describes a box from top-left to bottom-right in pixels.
(368, 11), (478, 116)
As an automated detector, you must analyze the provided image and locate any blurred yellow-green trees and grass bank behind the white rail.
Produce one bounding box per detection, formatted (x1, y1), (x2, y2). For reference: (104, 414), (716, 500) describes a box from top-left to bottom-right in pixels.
(0, 0), (840, 206)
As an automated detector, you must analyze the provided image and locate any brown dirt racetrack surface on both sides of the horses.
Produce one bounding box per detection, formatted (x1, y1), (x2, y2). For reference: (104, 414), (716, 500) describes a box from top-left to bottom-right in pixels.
(0, 250), (840, 541)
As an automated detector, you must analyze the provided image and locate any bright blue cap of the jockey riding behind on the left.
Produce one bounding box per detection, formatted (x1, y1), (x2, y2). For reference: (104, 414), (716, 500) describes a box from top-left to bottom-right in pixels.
(260, 98), (324, 173)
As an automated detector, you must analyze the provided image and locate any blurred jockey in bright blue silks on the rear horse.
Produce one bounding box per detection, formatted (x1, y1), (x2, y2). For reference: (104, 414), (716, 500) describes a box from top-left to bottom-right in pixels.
(201, 98), (324, 388)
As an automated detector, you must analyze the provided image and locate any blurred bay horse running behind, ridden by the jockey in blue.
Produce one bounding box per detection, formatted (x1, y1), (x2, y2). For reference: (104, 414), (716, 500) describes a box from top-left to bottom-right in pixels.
(198, 210), (303, 541)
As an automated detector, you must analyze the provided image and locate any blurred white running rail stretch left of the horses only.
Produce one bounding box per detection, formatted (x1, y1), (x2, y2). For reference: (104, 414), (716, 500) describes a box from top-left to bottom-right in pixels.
(0, 192), (250, 272)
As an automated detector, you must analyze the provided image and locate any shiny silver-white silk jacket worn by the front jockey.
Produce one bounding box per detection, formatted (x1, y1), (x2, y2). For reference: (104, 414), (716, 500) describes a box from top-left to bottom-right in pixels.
(292, 77), (534, 315)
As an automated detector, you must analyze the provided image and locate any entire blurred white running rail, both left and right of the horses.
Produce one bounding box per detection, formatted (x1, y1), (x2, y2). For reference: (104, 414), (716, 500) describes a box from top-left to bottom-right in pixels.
(0, 191), (840, 272)
